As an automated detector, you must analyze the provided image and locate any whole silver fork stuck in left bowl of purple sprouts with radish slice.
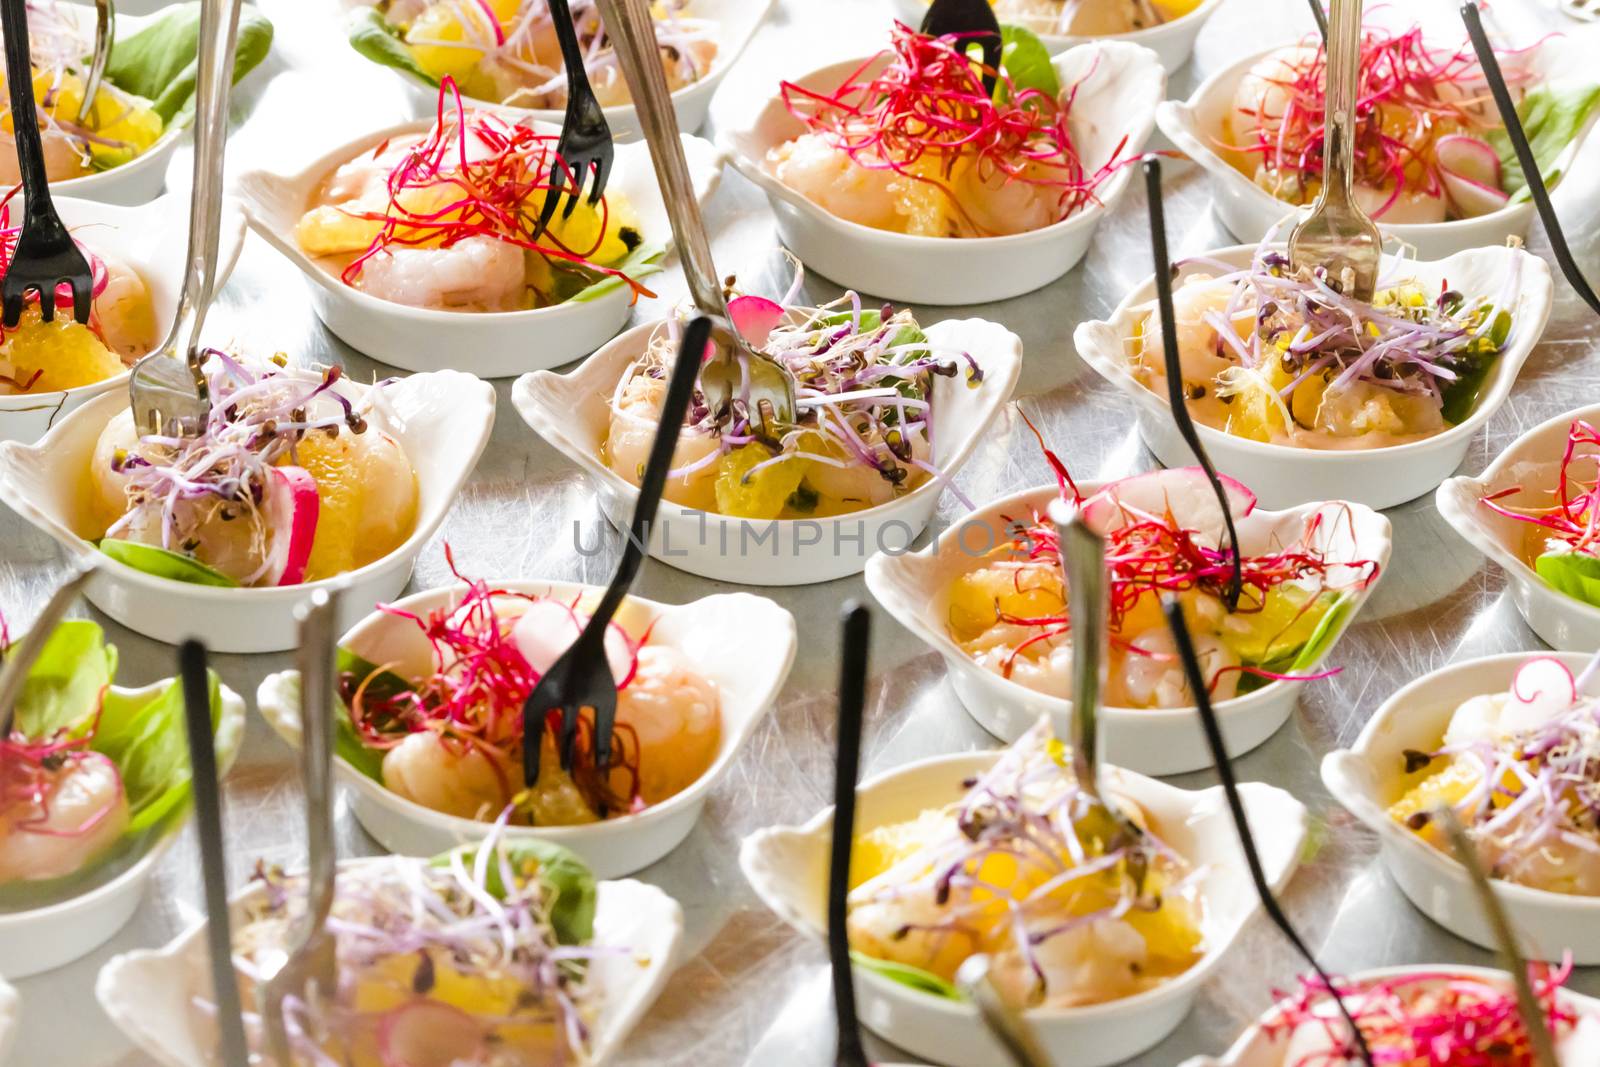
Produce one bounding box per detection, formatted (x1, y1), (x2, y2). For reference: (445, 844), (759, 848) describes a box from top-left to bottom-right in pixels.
(128, 0), (240, 435)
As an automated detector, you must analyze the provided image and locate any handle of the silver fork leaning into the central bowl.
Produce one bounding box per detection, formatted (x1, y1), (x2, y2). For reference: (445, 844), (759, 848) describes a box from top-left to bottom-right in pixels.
(597, 0), (728, 317)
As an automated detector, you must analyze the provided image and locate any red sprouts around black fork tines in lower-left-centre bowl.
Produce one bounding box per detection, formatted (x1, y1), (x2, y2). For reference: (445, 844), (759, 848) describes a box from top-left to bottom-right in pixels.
(339, 545), (650, 811)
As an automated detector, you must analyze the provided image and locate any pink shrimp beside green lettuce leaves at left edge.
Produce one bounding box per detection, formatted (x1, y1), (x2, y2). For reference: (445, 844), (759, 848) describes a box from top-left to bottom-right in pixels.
(0, 752), (128, 885)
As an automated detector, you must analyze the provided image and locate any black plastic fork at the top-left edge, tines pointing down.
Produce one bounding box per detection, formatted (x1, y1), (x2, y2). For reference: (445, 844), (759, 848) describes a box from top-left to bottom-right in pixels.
(0, 0), (94, 330)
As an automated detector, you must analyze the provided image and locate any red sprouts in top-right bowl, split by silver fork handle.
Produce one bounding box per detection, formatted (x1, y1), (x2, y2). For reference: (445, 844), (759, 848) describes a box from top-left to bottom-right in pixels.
(1226, 26), (1525, 218)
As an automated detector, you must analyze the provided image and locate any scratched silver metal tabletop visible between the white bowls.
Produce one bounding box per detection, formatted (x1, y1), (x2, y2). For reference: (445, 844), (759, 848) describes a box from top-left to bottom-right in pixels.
(0, 0), (1600, 1067)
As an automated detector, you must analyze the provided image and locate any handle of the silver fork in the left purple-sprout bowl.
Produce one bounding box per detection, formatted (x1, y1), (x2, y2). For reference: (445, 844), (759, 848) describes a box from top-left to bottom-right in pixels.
(163, 0), (240, 397)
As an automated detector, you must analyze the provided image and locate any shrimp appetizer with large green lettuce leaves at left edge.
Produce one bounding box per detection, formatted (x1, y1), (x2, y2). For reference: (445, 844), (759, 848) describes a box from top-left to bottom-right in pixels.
(0, 619), (221, 912)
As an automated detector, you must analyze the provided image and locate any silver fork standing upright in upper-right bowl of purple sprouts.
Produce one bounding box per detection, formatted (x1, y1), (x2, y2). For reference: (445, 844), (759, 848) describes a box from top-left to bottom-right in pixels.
(1290, 0), (1384, 301)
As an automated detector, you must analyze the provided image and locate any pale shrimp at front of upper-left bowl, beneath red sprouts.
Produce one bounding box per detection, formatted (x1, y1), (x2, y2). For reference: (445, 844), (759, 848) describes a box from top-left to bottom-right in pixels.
(358, 237), (528, 312)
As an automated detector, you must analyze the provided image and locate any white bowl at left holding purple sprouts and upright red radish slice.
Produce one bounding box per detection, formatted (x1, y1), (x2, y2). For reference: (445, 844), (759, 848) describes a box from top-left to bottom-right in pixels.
(0, 371), (494, 653)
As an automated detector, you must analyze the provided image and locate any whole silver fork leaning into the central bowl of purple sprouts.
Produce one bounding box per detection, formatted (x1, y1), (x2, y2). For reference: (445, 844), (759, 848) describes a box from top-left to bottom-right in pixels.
(598, 0), (795, 438)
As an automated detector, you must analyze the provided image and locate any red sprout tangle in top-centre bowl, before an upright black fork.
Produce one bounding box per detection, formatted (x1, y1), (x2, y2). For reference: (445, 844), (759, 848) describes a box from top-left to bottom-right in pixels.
(782, 21), (1128, 234)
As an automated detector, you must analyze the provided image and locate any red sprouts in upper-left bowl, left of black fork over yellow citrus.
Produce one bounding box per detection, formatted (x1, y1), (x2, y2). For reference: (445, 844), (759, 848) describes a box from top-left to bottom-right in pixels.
(339, 75), (654, 301)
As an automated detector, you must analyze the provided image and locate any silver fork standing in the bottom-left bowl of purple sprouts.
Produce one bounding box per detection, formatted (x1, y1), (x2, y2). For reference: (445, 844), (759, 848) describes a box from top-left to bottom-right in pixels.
(259, 589), (339, 1067)
